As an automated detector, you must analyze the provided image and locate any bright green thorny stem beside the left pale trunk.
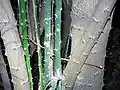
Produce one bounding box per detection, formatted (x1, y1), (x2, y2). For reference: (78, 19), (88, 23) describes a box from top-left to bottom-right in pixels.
(18, 0), (33, 90)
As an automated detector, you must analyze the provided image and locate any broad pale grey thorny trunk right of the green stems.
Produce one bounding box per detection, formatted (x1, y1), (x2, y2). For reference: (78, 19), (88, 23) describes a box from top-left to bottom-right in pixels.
(64, 0), (116, 90)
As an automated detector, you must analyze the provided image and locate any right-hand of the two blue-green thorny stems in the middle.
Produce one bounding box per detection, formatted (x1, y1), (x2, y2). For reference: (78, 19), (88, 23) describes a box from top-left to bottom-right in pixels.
(55, 0), (62, 90)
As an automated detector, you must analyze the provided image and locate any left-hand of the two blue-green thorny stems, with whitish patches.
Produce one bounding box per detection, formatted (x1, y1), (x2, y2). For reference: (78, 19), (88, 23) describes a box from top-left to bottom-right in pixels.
(44, 0), (51, 87)
